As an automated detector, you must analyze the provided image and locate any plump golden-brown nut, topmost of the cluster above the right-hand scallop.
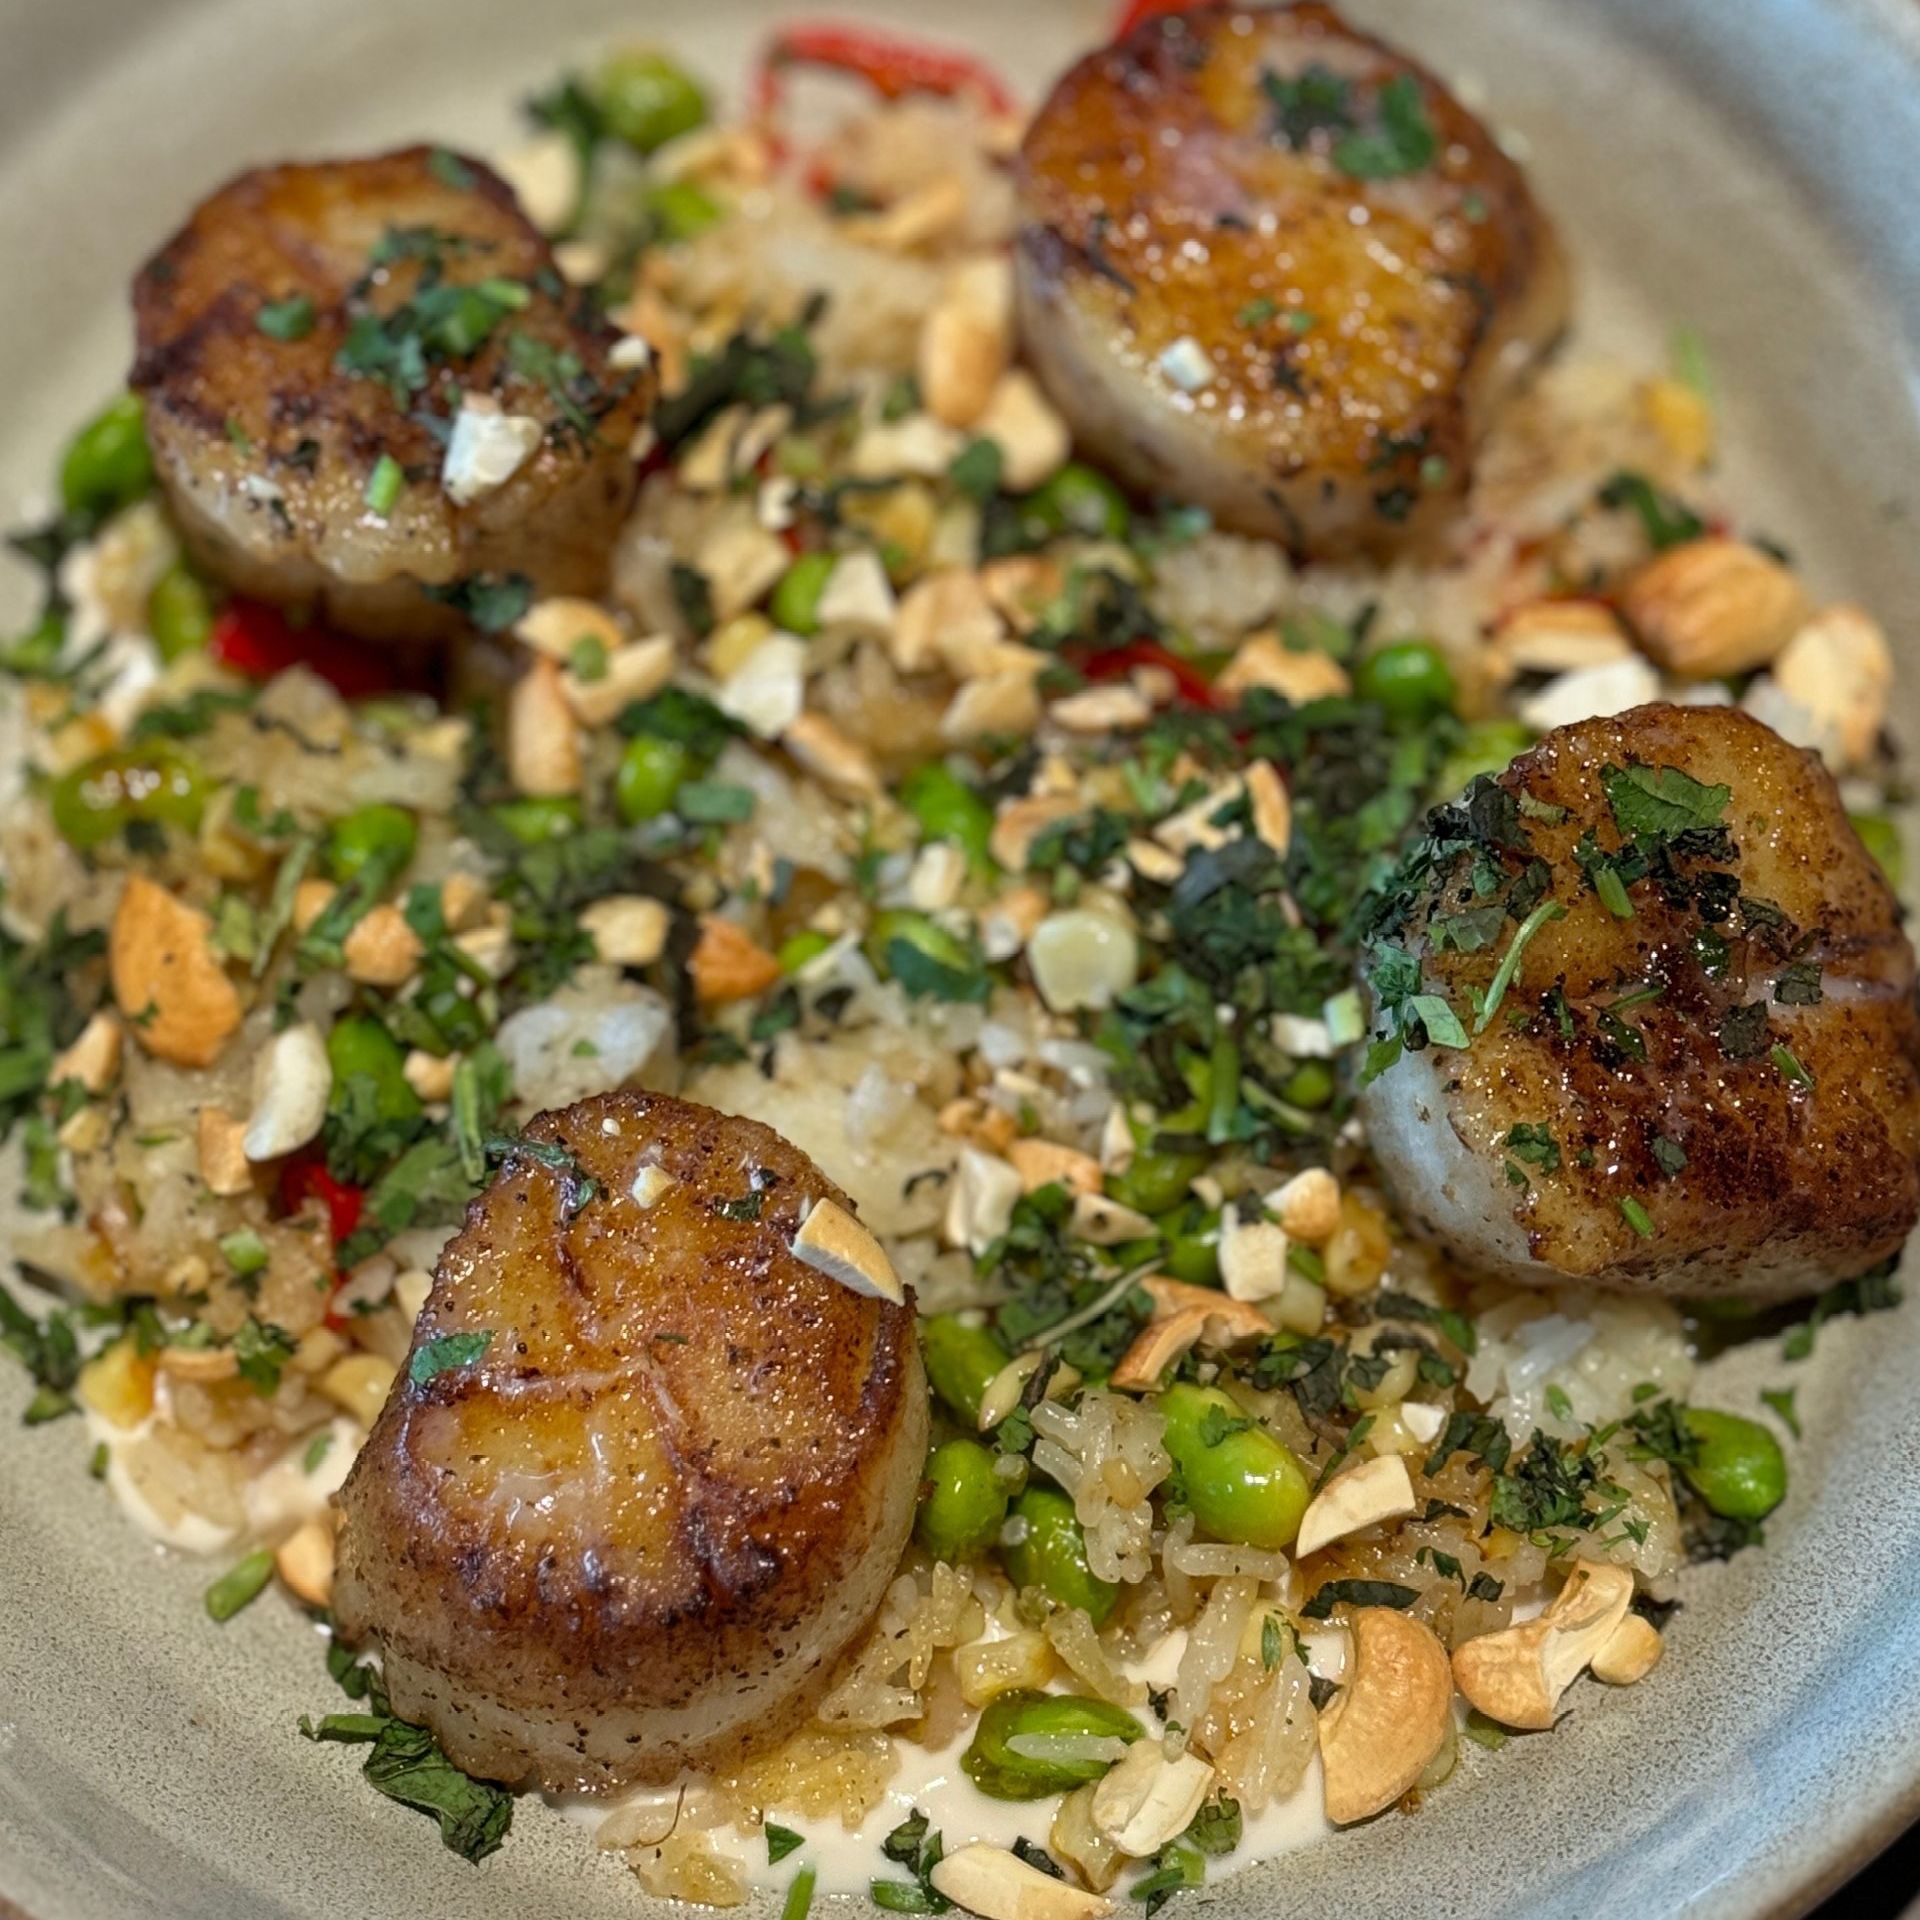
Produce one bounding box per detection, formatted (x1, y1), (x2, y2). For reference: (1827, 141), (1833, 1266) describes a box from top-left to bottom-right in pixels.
(1620, 536), (1807, 680)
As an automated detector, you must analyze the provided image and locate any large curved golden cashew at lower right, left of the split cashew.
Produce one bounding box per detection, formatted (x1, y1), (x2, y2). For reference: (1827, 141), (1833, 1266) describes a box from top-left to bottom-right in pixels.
(1319, 1607), (1453, 1826)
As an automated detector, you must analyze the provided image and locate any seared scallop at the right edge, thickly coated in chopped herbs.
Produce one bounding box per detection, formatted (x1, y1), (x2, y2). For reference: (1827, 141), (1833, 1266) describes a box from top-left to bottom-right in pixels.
(1361, 707), (1920, 1300)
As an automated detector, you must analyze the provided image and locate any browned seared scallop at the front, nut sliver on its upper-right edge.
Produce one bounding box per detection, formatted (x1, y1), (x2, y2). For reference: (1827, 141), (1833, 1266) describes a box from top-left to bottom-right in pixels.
(334, 1092), (927, 1788)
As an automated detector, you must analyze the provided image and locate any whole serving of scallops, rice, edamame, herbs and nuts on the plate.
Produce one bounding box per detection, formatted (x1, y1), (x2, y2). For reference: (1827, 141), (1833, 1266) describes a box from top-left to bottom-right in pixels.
(0, 6), (1916, 1920)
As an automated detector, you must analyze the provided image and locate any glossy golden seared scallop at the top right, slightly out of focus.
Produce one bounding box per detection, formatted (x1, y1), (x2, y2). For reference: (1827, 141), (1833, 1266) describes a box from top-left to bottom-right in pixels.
(1016, 4), (1567, 555)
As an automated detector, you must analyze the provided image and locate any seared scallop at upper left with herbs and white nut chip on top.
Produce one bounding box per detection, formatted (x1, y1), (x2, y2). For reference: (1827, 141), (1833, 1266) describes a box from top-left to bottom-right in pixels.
(132, 148), (649, 637)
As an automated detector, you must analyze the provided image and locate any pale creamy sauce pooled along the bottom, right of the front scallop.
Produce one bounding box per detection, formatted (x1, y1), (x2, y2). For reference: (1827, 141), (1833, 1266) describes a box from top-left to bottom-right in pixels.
(549, 1632), (1346, 1895)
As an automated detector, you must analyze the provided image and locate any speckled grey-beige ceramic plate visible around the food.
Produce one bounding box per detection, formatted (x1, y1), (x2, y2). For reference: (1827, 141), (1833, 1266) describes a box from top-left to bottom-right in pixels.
(0, 0), (1920, 1920)
